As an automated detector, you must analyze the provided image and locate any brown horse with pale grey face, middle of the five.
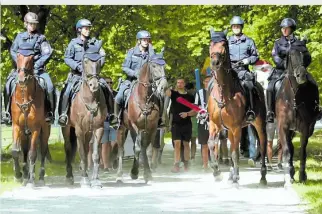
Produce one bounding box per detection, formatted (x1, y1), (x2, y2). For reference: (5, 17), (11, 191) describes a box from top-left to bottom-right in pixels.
(117, 55), (167, 182)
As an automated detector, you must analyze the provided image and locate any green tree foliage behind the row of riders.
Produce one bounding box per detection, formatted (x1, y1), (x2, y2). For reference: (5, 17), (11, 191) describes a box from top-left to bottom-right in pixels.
(0, 5), (322, 96)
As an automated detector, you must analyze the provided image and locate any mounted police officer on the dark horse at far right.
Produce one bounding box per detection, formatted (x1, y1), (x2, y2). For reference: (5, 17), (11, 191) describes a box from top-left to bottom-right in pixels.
(266, 18), (319, 123)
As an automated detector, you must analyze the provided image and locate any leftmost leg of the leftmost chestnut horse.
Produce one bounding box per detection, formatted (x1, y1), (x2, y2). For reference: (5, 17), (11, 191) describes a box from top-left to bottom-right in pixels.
(11, 124), (22, 182)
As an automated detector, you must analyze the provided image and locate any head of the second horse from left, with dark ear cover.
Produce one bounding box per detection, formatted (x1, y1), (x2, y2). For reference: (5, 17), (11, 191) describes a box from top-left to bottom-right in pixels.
(82, 41), (102, 93)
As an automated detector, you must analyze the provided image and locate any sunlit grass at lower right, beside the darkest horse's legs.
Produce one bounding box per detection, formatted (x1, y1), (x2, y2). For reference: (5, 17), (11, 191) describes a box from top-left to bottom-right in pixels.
(294, 130), (322, 214)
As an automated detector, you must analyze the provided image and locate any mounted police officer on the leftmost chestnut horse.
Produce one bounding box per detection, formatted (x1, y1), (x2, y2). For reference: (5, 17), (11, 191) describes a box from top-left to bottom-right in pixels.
(2, 12), (56, 125)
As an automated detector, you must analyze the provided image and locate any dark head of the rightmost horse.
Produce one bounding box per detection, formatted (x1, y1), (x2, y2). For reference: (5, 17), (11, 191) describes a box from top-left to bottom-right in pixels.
(286, 49), (307, 84)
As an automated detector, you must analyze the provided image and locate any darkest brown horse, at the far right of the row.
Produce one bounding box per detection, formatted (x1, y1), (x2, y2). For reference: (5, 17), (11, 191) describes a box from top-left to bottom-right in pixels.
(275, 49), (318, 187)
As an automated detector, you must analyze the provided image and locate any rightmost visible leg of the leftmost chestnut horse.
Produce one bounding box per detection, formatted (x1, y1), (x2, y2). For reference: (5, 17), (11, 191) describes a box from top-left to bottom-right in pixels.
(39, 124), (50, 186)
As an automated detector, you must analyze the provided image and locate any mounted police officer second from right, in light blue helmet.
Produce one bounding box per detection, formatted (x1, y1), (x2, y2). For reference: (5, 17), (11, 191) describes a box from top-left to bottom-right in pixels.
(228, 16), (259, 122)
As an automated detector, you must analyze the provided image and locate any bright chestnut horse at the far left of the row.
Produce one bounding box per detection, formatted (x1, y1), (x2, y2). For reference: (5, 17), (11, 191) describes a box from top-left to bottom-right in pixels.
(11, 53), (50, 187)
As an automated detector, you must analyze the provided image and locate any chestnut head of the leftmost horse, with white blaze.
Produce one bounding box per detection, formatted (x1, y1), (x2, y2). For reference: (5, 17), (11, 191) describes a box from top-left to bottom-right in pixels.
(17, 50), (35, 85)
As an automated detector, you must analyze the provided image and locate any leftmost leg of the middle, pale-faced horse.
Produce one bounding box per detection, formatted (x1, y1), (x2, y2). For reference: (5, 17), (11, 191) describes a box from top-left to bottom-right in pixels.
(116, 126), (127, 183)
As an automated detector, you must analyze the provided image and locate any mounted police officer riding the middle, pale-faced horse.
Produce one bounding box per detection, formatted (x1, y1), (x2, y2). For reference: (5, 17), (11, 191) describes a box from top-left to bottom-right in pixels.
(111, 30), (155, 125)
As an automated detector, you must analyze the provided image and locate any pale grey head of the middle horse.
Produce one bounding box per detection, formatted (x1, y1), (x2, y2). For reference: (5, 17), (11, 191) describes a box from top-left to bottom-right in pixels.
(148, 50), (168, 97)
